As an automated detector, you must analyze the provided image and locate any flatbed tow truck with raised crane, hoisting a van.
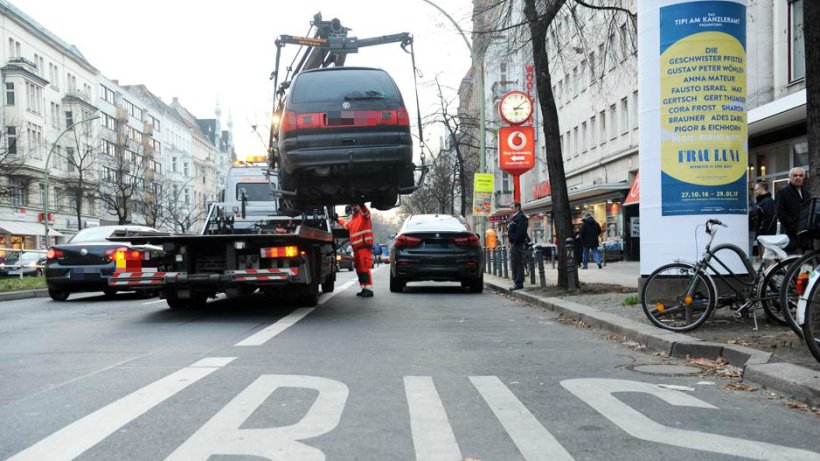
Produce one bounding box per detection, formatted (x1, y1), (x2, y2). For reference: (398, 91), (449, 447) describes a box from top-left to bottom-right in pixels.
(109, 14), (423, 309)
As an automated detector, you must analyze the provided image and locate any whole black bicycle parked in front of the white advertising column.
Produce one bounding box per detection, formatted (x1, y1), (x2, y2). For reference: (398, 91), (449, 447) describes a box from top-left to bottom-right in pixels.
(640, 219), (797, 332)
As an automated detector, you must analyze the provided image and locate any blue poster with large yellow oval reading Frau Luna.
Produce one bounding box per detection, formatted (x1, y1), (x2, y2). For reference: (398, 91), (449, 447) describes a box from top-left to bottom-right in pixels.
(660, 1), (748, 216)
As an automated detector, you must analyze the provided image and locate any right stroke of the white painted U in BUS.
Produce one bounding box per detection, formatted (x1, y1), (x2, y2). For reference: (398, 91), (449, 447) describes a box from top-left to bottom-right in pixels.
(470, 376), (574, 461)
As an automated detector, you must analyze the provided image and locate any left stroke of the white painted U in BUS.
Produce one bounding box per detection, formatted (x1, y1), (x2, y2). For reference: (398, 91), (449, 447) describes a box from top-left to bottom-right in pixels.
(404, 376), (462, 461)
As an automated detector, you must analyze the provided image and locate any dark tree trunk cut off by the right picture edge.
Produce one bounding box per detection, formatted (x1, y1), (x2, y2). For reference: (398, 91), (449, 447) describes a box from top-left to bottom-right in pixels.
(803, 0), (820, 197)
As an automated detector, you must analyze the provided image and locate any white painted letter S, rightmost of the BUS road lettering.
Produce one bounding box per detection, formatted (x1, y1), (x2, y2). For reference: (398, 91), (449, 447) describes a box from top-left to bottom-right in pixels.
(561, 378), (820, 461)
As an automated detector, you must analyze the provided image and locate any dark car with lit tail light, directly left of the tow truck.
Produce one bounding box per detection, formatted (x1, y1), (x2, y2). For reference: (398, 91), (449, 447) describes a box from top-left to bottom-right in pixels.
(46, 225), (162, 301)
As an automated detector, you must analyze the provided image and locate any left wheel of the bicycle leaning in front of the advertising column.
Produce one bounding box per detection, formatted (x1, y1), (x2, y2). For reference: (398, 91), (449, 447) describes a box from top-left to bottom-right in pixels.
(641, 263), (717, 331)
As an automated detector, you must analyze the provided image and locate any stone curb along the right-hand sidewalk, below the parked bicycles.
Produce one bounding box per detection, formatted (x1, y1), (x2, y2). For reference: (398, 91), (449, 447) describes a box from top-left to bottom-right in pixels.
(484, 279), (820, 406)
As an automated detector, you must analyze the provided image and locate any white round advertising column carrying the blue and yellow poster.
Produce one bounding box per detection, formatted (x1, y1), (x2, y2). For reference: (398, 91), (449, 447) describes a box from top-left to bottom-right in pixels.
(638, 0), (748, 275)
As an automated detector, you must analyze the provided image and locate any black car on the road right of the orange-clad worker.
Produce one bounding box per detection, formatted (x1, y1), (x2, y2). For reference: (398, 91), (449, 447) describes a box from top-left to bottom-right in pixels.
(390, 215), (484, 293)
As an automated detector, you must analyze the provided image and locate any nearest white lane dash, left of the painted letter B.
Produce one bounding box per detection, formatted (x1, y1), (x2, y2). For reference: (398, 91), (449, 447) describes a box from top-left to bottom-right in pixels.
(9, 357), (236, 461)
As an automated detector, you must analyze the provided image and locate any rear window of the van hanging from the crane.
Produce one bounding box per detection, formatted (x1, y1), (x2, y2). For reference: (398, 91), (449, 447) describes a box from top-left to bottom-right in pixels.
(290, 69), (399, 103)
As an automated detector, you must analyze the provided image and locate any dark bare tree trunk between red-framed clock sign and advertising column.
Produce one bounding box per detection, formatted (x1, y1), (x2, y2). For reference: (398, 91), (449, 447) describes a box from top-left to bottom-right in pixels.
(524, 0), (573, 287)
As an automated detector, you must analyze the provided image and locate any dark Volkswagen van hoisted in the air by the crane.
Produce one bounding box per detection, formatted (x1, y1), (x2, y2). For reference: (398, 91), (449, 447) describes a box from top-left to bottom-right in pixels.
(279, 67), (415, 210)
